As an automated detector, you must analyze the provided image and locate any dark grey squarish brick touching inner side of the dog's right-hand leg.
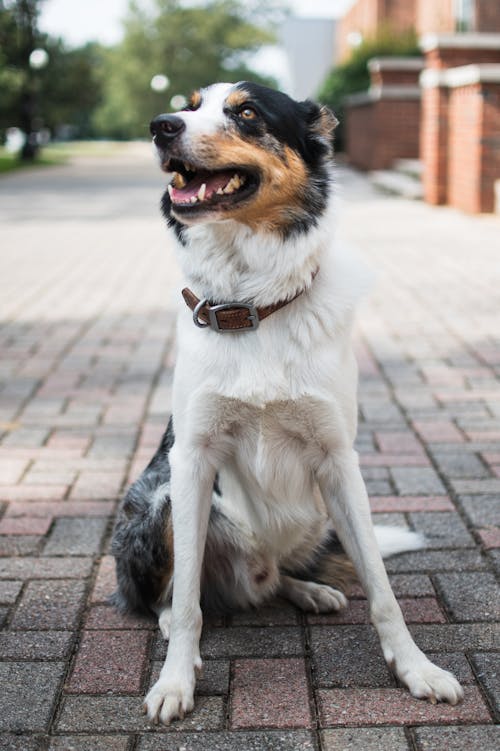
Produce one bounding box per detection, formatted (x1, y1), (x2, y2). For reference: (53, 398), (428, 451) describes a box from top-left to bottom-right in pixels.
(311, 626), (394, 687)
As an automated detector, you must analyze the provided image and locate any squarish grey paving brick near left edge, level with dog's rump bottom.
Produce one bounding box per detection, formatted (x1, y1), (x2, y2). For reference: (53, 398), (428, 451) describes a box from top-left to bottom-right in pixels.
(11, 580), (85, 630)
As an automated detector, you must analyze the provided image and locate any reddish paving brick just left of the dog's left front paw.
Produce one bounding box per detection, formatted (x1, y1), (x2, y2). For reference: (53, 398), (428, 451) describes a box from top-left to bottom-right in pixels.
(65, 631), (149, 694)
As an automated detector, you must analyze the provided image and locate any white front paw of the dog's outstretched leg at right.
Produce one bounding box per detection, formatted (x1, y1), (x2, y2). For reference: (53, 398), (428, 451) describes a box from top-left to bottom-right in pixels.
(392, 653), (464, 705)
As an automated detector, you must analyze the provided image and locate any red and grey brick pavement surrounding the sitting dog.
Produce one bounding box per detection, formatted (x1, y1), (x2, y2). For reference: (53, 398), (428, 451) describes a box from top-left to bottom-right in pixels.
(0, 147), (500, 751)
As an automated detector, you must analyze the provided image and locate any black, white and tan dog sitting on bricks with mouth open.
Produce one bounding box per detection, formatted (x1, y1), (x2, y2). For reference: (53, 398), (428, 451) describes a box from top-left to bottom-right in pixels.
(112, 82), (463, 724)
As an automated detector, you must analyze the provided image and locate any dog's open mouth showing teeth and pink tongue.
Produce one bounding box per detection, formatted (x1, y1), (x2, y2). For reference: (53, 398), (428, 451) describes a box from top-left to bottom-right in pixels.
(163, 159), (259, 213)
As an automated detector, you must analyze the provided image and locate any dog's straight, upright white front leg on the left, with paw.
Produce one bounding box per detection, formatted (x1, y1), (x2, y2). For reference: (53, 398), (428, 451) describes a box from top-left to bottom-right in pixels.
(144, 442), (215, 725)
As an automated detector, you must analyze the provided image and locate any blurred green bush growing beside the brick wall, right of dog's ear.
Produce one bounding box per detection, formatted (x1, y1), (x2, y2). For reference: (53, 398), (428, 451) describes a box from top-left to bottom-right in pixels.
(318, 27), (421, 149)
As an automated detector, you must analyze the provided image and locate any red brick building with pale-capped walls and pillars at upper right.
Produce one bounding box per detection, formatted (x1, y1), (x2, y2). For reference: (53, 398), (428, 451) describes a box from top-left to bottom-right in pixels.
(338, 0), (500, 213)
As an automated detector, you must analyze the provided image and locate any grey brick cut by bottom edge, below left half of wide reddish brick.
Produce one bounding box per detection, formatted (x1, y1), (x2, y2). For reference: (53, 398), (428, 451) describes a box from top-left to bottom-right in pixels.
(321, 728), (410, 751)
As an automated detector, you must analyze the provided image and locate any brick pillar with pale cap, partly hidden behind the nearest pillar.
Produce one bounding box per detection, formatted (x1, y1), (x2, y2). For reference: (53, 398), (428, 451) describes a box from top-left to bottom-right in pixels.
(420, 33), (500, 204)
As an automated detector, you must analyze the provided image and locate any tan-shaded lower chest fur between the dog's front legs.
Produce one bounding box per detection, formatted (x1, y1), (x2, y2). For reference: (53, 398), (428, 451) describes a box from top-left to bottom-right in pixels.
(205, 397), (337, 553)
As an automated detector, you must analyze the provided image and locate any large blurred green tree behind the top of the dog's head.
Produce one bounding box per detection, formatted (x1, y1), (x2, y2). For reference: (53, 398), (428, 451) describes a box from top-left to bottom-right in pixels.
(94, 0), (279, 138)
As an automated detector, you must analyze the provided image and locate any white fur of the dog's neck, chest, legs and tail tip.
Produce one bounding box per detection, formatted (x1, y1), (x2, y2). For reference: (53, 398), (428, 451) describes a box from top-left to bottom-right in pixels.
(146, 88), (462, 723)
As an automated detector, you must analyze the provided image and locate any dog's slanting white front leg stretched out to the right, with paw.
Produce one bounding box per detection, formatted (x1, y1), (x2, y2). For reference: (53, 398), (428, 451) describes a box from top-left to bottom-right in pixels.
(318, 450), (463, 704)
